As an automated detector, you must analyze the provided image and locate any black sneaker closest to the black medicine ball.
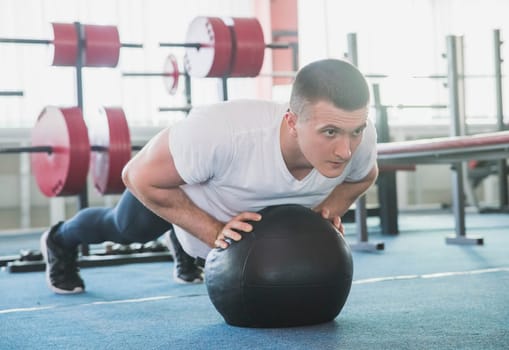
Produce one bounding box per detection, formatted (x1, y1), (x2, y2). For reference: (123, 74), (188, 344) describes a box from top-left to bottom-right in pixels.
(166, 230), (203, 284)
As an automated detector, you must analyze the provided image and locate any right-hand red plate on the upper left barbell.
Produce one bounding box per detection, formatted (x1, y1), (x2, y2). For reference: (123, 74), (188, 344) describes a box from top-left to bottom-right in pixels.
(83, 24), (121, 67)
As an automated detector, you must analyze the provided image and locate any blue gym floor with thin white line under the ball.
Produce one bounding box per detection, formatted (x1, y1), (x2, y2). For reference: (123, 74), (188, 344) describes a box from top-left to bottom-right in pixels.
(0, 211), (509, 350)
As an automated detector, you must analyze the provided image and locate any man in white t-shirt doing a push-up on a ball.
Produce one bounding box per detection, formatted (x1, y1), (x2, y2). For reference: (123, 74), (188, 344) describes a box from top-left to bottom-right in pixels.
(42, 59), (378, 289)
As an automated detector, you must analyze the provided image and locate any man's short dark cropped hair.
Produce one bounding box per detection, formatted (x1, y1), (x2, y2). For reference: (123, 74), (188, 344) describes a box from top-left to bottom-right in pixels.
(290, 59), (369, 113)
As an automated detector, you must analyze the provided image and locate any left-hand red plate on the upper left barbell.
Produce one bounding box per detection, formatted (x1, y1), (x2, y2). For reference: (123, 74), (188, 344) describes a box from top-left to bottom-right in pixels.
(51, 23), (78, 66)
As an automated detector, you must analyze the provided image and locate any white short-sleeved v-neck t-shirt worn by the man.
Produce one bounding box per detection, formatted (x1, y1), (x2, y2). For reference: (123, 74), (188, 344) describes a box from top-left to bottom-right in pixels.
(169, 100), (376, 258)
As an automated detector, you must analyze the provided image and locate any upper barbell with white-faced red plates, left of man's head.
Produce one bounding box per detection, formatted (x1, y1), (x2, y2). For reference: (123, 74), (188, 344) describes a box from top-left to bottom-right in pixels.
(159, 16), (294, 78)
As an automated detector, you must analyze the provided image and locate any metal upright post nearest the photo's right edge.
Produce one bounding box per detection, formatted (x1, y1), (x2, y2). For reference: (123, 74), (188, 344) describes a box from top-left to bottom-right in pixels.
(493, 29), (509, 209)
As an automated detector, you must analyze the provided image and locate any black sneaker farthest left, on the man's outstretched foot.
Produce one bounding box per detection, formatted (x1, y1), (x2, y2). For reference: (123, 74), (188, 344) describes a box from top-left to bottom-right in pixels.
(41, 222), (85, 294)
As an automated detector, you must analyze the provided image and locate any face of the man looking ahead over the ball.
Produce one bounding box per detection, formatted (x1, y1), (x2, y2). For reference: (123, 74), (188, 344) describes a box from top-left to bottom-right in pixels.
(296, 101), (368, 178)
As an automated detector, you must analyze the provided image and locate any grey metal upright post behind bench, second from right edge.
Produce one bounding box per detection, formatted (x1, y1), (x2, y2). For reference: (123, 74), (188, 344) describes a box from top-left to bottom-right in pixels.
(446, 35), (483, 244)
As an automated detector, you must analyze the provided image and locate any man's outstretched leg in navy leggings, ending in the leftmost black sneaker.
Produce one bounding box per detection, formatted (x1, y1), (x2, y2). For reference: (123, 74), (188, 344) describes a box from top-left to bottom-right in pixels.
(41, 191), (201, 294)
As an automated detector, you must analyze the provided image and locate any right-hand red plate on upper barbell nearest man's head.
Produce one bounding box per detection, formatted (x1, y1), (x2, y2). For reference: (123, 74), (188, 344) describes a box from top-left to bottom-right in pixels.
(226, 18), (265, 77)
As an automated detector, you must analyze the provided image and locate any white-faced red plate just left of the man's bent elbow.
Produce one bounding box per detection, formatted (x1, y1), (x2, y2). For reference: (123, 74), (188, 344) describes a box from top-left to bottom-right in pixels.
(90, 108), (131, 194)
